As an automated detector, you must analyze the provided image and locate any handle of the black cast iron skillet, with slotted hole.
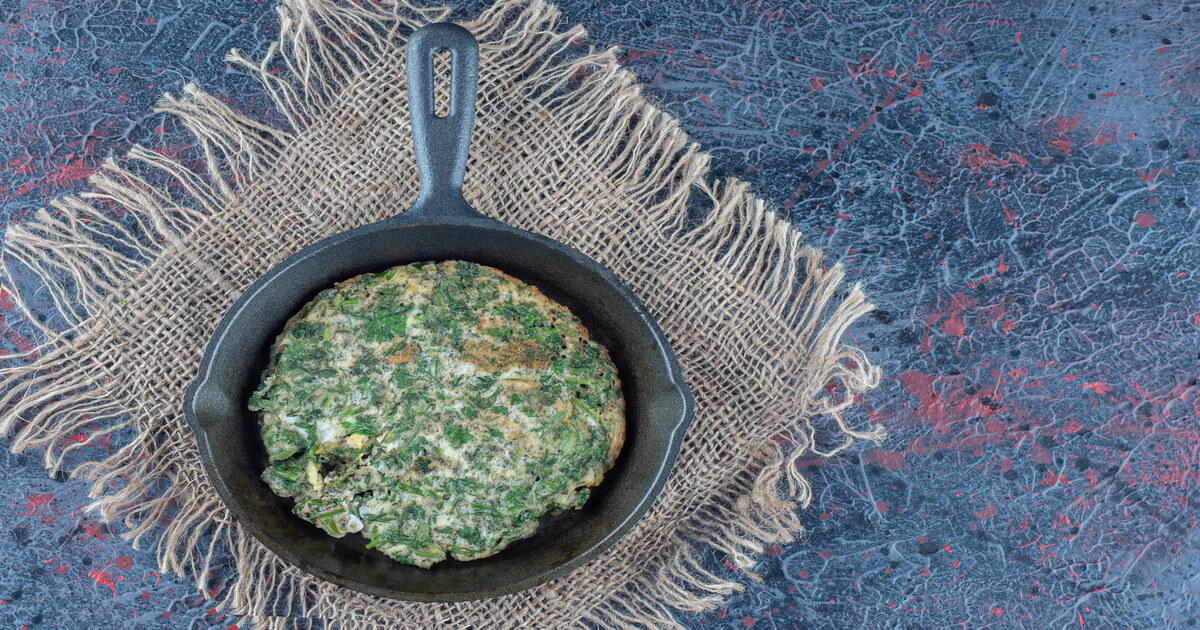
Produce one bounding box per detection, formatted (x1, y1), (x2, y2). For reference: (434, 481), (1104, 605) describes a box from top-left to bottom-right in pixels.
(404, 22), (479, 214)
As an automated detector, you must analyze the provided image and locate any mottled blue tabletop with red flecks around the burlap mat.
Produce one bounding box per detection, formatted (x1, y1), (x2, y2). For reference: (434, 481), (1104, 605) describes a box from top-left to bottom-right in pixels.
(0, 0), (1200, 629)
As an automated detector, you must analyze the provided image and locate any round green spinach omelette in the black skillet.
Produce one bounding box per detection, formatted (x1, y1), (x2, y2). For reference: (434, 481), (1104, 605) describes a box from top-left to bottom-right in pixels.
(250, 260), (625, 566)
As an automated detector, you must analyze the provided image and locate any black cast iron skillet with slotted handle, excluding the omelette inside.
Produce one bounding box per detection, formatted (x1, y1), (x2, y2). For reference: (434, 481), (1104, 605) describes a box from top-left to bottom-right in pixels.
(184, 23), (695, 601)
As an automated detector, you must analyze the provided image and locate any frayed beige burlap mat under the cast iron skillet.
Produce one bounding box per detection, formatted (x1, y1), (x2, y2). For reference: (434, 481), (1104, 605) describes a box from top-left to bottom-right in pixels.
(0, 0), (882, 629)
